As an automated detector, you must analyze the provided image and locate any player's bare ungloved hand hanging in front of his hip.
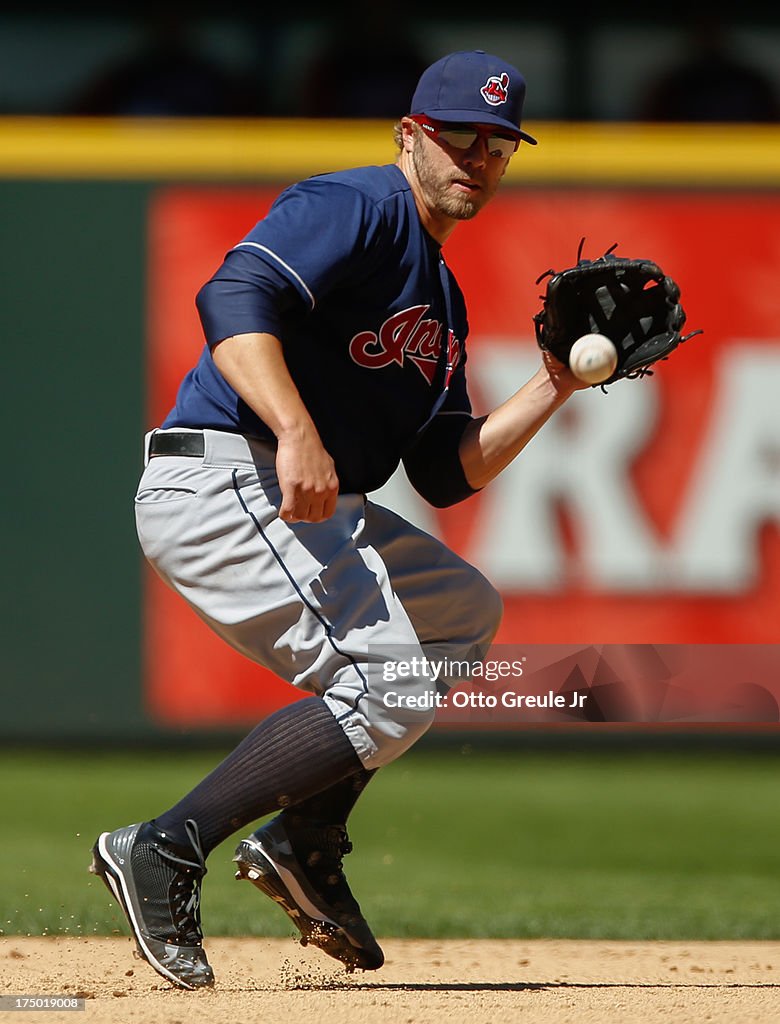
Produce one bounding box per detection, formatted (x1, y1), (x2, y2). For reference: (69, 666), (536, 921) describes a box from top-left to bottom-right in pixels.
(276, 434), (339, 522)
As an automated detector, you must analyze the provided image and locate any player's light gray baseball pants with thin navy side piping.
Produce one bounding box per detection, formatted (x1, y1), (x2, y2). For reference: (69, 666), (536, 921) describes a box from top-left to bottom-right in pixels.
(135, 430), (502, 768)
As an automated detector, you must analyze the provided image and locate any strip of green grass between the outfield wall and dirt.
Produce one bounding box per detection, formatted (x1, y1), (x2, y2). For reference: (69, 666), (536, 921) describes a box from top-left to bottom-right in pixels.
(0, 751), (780, 939)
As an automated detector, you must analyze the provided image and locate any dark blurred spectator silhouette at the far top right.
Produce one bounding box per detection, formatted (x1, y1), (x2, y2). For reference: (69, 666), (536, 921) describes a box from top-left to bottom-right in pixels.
(639, 17), (780, 123)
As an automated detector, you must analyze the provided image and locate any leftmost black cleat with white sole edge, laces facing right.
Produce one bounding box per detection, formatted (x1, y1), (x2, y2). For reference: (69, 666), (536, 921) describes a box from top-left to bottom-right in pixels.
(89, 820), (214, 989)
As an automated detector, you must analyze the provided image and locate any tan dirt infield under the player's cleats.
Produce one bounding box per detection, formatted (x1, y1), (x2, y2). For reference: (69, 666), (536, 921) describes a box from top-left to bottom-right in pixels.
(0, 936), (780, 1024)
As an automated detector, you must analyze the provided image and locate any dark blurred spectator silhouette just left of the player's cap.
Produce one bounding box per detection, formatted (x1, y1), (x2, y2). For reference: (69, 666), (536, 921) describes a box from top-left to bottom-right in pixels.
(297, 3), (430, 118)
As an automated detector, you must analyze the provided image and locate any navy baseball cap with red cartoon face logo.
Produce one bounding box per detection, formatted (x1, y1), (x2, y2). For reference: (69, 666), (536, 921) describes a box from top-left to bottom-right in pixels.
(409, 50), (536, 145)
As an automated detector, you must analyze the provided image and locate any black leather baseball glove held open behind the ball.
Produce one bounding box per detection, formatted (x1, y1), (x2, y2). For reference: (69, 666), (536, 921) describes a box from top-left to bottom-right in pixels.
(533, 239), (702, 387)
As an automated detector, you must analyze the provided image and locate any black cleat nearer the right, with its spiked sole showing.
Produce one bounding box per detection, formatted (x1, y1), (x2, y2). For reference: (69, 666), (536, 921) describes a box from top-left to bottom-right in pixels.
(233, 812), (385, 972)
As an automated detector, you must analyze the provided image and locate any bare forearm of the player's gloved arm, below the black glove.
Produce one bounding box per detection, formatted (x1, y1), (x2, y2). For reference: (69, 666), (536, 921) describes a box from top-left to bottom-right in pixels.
(460, 364), (581, 490)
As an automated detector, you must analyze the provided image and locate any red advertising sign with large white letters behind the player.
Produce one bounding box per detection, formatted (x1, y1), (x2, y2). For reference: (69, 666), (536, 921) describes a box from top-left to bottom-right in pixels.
(144, 187), (780, 725)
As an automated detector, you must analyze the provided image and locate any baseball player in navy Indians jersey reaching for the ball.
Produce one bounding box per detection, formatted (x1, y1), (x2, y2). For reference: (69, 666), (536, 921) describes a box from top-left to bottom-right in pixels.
(92, 50), (584, 989)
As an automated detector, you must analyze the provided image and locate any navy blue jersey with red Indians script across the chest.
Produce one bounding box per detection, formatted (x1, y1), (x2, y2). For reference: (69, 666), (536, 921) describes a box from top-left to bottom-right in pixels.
(163, 165), (471, 493)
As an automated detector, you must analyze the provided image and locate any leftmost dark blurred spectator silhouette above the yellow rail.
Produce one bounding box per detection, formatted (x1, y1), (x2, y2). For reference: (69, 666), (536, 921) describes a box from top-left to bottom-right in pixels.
(68, 13), (263, 117)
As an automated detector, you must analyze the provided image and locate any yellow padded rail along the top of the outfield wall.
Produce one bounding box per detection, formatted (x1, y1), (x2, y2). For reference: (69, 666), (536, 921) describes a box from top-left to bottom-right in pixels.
(0, 117), (780, 188)
